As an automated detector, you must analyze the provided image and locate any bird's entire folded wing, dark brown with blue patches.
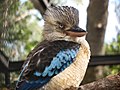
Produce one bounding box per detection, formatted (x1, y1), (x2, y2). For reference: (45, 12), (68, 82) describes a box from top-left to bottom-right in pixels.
(16, 40), (80, 90)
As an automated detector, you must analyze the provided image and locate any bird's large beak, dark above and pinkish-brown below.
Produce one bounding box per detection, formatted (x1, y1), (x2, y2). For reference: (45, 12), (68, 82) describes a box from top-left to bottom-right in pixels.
(65, 26), (87, 37)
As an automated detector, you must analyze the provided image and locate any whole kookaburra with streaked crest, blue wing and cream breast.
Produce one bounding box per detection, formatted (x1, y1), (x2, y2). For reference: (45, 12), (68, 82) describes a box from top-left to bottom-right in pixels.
(16, 6), (90, 90)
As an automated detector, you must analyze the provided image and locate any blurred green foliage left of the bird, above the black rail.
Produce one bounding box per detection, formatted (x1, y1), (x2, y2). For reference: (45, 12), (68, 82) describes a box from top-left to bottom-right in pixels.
(0, 0), (42, 61)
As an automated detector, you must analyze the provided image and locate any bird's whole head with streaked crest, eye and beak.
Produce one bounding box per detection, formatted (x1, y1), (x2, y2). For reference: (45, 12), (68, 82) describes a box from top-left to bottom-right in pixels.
(43, 6), (87, 41)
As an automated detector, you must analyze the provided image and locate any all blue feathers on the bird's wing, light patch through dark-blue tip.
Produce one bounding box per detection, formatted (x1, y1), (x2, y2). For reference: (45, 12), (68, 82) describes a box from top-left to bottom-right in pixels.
(16, 40), (79, 90)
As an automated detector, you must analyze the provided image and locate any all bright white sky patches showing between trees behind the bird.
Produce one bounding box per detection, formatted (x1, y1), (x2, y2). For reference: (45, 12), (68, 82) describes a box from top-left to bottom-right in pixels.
(21, 0), (119, 43)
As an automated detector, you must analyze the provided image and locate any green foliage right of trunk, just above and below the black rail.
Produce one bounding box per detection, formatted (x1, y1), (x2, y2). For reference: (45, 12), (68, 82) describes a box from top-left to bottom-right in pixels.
(105, 33), (120, 75)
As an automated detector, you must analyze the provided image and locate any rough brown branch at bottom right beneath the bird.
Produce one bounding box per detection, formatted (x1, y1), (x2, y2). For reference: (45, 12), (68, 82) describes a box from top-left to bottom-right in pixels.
(66, 73), (120, 90)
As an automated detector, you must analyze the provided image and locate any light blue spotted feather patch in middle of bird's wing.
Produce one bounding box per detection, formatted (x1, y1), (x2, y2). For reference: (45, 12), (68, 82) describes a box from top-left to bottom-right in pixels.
(43, 48), (79, 75)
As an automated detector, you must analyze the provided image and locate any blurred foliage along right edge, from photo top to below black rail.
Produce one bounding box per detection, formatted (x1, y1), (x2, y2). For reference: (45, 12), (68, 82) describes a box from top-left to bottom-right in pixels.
(105, 0), (120, 75)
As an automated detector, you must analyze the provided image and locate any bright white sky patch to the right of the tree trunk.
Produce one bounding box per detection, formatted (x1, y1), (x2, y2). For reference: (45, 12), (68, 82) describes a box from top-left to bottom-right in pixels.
(105, 0), (119, 43)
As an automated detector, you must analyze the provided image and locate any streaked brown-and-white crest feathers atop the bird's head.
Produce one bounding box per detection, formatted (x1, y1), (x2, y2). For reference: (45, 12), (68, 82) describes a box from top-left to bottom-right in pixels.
(44, 6), (79, 26)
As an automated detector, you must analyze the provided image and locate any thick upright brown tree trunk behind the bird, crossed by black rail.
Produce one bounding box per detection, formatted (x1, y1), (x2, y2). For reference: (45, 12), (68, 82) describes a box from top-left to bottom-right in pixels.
(83, 0), (109, 83)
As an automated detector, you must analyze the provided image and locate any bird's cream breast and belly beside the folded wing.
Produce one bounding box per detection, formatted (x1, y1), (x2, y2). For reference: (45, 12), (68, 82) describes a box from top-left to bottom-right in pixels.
(40, 38), (90, 90)
